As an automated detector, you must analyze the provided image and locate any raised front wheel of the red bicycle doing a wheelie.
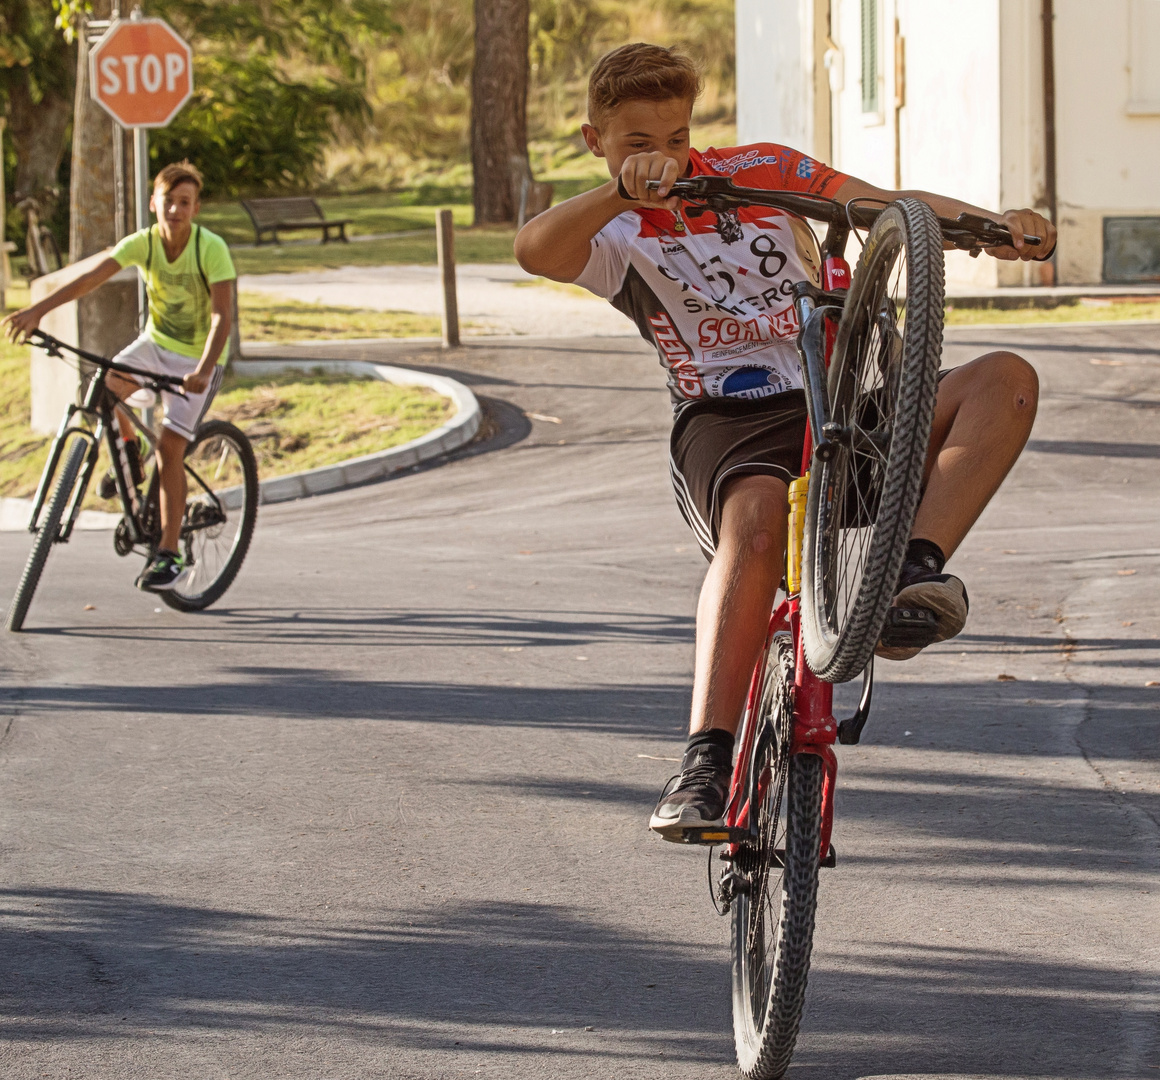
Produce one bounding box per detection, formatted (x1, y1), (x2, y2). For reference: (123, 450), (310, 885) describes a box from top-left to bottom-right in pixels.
(802, 198), (943, 682)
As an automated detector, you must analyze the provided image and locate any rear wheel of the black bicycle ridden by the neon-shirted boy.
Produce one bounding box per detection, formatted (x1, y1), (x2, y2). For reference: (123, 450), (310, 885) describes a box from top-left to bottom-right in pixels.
(159, 420), (258, 611)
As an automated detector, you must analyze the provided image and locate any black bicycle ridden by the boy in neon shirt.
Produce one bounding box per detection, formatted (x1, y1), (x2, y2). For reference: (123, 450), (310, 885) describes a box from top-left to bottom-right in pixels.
(6, 329), (258, 631)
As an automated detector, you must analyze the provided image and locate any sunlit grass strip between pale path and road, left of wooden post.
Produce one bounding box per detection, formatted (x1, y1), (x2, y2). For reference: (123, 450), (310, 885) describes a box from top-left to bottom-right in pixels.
(238, 292), (442, 341)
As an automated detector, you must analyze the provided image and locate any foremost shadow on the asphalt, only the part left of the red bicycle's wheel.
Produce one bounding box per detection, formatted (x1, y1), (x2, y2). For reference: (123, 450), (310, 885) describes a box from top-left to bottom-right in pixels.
(0, 889), (728, 1064)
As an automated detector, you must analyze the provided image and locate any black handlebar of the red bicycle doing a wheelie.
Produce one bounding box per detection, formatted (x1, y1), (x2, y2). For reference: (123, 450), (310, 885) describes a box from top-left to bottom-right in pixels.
(648, 176), (1043, 252)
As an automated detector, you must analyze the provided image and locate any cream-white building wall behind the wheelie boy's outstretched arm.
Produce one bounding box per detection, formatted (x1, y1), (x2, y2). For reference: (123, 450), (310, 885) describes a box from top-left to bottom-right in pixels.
(737, 0), (1160, 288)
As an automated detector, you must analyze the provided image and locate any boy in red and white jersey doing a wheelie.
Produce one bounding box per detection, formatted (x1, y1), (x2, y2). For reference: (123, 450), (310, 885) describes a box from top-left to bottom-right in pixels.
(515, 44), (1056, 840)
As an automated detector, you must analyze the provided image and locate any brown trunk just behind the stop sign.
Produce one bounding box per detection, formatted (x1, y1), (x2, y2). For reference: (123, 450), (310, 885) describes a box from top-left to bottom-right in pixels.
(68, 0), (121, 262)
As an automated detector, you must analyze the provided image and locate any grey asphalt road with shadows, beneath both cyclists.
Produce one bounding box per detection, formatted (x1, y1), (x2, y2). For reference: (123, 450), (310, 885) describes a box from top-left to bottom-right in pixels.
(0, 325), (1160, 1080)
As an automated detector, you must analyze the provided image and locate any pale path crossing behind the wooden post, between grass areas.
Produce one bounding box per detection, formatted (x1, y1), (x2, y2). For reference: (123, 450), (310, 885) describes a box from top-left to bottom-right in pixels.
(238, 263), (637, 338)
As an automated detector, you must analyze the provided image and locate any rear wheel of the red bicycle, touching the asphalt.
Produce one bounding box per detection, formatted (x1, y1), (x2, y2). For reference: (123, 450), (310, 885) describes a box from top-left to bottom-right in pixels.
(731, 633), (825, 1080)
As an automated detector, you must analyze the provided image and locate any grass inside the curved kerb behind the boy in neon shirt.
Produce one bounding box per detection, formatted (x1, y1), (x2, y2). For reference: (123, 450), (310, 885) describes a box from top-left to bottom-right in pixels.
(0, 343), (454, 510)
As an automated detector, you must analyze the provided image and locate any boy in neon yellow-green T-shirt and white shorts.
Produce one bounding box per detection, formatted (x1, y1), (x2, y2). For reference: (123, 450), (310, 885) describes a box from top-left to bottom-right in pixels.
(0, 161), (238, 593)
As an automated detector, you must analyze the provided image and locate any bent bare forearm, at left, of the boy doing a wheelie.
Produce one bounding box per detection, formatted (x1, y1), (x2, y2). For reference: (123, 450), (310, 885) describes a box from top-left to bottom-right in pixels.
(515, 180), (633, 282)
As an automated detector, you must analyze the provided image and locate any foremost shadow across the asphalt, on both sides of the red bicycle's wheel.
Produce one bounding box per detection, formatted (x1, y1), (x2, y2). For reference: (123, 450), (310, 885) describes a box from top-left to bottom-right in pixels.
(0, 889), (1146, 1078)
